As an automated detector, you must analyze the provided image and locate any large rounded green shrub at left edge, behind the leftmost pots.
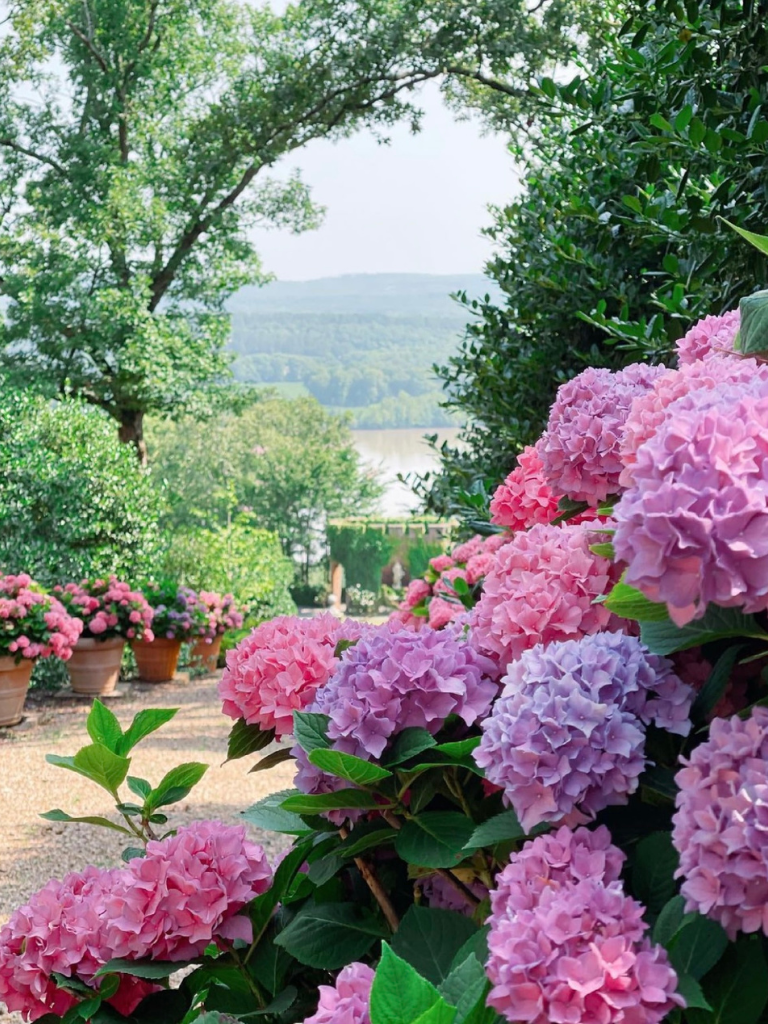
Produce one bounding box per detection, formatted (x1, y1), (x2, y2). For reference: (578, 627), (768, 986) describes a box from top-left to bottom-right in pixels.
(0, 388), (161, 586)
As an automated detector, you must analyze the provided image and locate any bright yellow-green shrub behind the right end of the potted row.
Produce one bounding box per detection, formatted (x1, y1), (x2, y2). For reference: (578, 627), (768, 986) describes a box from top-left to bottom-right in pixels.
(163, 515), (296, 627)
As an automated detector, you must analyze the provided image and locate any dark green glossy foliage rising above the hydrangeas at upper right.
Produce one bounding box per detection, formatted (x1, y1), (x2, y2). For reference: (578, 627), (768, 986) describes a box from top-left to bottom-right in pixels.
(423, 0), (768, 510)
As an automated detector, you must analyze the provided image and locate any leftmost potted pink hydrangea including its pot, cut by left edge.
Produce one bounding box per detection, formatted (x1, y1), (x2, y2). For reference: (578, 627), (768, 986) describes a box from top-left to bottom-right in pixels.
(0, 572), (83, 725)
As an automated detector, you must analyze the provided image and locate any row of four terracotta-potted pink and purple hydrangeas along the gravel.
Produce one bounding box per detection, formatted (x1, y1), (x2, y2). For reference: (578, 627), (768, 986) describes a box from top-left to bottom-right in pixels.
(0, 573), (243, 726)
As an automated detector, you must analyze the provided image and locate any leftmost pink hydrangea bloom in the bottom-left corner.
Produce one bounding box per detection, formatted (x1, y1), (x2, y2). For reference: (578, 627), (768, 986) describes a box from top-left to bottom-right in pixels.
(0, 867), (155, 1021)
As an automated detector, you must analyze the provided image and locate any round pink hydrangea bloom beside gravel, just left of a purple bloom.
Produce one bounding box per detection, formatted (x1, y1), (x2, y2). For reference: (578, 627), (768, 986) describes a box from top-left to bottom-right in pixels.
(219, 613), (365, 736)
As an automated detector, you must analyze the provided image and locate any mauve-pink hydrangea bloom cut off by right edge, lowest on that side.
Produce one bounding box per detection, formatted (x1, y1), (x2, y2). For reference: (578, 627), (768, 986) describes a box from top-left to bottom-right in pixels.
(672, 708), (768, 939)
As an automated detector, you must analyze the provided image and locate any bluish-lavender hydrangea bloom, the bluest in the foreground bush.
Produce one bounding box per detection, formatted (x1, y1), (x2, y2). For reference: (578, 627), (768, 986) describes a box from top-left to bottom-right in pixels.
(474, 633), (693, 831)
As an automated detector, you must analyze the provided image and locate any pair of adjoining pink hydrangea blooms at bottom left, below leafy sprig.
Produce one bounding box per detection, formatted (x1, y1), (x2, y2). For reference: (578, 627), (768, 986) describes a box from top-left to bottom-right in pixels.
(0, 821), (271, 1020)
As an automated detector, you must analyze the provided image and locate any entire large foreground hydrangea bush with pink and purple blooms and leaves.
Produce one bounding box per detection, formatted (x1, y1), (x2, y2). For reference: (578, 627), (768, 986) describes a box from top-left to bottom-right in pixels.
(7, 274), (768, 1024)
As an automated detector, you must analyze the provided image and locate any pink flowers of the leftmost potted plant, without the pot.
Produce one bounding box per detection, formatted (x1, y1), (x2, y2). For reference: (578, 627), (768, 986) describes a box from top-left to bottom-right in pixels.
(0, 573), (83, 662)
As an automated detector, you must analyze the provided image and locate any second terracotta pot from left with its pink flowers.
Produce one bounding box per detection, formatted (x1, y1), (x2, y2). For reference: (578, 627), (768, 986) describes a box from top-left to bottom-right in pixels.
(53, 575), (153, 696)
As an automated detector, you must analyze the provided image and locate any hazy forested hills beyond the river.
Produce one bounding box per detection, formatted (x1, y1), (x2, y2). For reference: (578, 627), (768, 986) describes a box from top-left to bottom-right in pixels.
(229, 273), (499, 427)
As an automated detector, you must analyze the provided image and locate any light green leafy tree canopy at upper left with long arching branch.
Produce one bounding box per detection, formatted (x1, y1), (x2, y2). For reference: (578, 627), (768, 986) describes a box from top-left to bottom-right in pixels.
(0, 0), (593, 454)
